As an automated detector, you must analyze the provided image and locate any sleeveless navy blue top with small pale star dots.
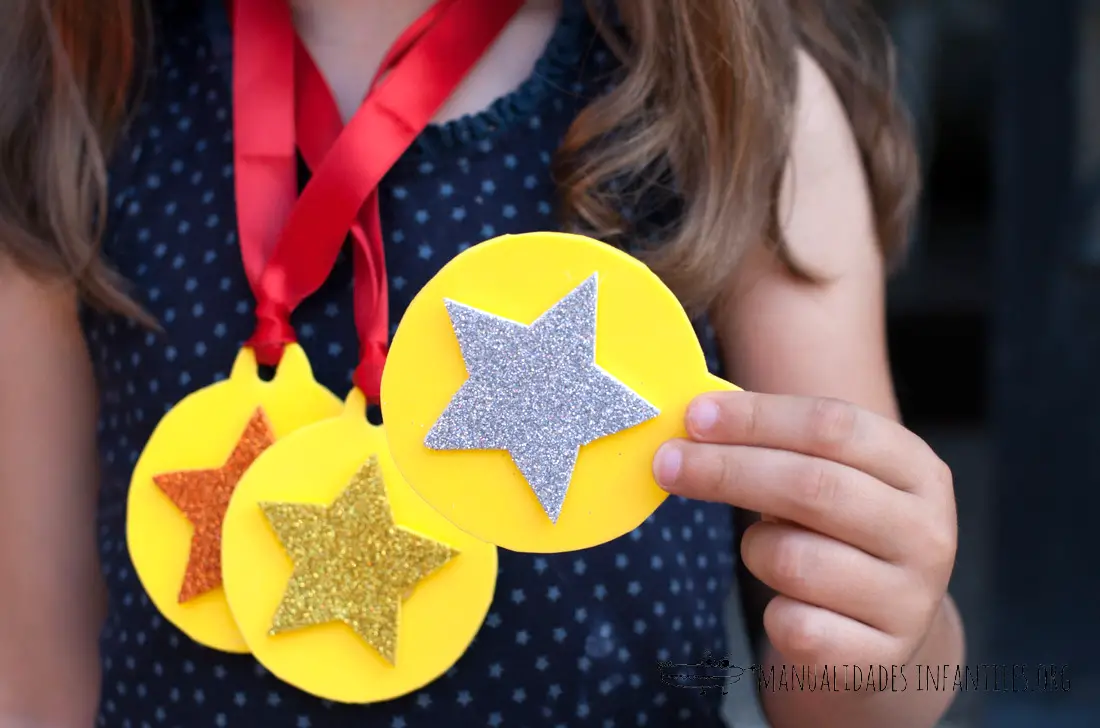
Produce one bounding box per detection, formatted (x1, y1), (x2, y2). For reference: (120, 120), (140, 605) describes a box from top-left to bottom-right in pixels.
(85, 0), (735, 728)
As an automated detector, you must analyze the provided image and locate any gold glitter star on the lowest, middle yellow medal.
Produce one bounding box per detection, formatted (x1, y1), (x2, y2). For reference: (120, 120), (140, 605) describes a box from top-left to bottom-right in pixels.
(260, 455), (459, 664)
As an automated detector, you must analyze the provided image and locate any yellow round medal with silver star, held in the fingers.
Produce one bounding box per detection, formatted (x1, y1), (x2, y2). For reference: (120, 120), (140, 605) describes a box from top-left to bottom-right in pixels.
(382, 233), (737, 552)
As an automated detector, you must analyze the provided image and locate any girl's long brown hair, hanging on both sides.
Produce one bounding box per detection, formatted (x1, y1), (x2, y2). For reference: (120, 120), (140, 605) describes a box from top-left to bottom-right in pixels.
(0, 0), (917, 318)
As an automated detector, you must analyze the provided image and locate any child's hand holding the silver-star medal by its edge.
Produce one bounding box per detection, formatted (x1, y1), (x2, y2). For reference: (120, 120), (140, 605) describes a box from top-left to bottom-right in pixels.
(655, 393), (956, 665)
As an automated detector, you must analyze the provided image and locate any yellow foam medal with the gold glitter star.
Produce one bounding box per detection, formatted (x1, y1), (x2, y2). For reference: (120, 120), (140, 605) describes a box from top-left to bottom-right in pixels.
(222, 389), (497, 703)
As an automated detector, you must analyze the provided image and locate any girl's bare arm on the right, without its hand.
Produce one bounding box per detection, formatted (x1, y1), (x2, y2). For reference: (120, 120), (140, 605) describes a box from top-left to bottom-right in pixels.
(714, 56), (963, 728)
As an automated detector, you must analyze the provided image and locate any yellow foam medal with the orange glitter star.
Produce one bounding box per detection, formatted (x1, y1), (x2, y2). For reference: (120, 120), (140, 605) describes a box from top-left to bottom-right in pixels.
(127, 344), (340, 652)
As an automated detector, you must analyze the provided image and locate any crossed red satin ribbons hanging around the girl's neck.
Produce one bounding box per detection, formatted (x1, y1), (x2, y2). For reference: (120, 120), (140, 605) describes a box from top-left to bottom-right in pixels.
(231, 0), (523, 401)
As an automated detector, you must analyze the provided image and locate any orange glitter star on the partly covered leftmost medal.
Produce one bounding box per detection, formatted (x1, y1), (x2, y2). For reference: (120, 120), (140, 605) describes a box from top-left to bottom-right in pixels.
(153, 408), (275, 604)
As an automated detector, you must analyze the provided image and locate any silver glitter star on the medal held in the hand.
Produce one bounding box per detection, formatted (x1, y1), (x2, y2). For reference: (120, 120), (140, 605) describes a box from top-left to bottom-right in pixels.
(425, 274), (659, 522)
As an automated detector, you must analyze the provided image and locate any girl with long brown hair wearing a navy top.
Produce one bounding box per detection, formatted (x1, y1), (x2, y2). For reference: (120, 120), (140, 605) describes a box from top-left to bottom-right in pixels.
(0, 0), (963, 728)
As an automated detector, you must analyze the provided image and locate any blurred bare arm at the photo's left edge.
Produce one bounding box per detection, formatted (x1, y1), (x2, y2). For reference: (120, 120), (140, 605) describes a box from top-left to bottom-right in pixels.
(0, 265), (105, 728)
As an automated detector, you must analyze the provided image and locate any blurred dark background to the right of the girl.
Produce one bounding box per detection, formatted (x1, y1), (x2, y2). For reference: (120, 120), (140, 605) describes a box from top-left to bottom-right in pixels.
(732, 0), (1100, 728)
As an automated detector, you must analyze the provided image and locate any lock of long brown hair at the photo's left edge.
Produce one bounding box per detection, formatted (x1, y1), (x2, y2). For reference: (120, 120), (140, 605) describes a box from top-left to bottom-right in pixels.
(0, 0), (147, 321)
